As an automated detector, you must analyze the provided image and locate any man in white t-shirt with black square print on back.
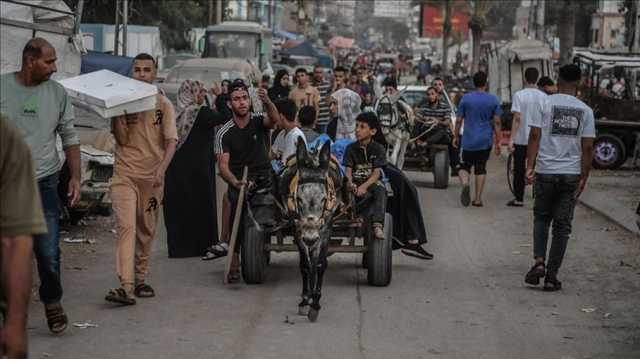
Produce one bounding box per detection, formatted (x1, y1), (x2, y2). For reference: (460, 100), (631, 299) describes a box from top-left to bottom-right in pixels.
(525, 64), (596, 291)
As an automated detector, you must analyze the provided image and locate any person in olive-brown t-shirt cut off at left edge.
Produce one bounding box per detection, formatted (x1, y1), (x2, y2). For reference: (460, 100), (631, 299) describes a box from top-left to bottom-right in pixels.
(0, 115), (47, 359)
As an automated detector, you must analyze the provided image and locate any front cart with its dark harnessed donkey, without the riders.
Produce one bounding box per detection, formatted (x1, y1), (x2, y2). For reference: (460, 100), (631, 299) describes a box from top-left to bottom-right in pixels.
(240, 140), (393, 321)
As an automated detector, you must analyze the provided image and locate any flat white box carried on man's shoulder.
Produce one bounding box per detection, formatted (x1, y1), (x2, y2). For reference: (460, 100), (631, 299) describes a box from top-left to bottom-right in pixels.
(60, 70), (158, 119)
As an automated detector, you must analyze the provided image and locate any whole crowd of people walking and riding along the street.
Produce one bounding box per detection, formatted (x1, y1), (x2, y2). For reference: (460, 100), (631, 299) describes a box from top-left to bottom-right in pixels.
(0, 38), (595, 358)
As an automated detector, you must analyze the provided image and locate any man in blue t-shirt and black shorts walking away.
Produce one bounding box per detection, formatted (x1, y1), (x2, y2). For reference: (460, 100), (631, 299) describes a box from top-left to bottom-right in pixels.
(453, 71), (502, 207)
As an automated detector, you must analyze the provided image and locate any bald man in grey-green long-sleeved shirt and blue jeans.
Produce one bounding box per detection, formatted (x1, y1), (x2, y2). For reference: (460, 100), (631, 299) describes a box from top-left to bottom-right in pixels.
(0, 38), (80, 334)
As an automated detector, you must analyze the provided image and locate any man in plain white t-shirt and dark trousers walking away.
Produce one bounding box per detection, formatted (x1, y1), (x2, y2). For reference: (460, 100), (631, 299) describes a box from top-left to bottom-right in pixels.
(507, 67), (547, 207)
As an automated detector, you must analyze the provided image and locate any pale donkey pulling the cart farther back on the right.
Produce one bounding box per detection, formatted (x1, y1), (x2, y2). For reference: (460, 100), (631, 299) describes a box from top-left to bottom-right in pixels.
(374, 92), (415, 169)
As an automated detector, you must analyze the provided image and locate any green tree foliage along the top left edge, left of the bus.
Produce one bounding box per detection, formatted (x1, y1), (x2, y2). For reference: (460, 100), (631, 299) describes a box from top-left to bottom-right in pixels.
(82, 0), (209, 50)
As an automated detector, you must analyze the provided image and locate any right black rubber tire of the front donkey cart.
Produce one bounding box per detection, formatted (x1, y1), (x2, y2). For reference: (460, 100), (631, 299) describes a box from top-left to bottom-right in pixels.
(366, 213), (393, 287)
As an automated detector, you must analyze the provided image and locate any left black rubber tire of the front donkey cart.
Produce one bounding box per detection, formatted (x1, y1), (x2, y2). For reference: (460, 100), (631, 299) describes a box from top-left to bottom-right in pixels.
(240, 226), (267, 284)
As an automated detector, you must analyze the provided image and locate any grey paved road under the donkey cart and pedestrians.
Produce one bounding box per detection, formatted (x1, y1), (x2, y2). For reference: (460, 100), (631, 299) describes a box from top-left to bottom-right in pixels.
(29, 159), (640, 359)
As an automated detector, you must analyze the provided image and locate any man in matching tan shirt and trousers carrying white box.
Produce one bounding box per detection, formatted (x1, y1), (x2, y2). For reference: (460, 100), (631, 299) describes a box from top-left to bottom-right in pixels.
(105, 54), (178, 305)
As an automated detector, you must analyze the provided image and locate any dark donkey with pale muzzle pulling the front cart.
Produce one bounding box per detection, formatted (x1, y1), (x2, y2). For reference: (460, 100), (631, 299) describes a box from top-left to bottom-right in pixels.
(287, 139), (342, 322)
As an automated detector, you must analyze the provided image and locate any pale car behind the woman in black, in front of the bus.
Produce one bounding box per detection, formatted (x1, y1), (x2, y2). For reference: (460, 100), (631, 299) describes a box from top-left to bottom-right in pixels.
(158, 58), (262, 103)
